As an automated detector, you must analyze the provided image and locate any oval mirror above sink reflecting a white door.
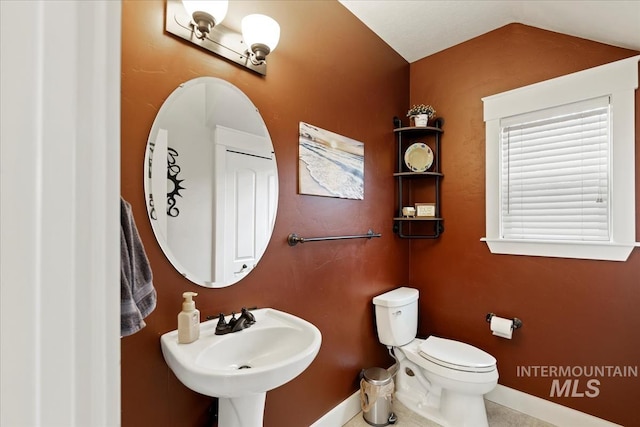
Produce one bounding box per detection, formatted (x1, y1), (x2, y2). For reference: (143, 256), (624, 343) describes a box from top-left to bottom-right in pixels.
(144, 77), (278, 288)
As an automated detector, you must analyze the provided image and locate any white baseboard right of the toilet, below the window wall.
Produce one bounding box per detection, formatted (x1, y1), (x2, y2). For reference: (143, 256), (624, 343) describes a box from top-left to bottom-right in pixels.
(484, 384), (621, 427)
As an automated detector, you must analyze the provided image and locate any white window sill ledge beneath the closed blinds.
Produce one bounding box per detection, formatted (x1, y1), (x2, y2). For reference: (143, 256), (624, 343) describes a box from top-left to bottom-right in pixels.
(480, 237), (640, 261)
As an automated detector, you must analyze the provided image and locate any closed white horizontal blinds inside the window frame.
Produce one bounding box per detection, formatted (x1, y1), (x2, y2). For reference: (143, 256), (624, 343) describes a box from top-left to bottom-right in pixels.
(500, 97), (610, 241)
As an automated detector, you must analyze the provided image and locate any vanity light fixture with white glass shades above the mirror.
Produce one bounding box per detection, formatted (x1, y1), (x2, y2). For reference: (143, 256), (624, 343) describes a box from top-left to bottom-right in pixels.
(165, 0), (280, 75)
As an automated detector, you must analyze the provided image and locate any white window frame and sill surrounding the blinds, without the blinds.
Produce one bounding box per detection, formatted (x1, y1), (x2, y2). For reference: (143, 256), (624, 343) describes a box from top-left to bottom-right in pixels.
(481, 55), (640, 261)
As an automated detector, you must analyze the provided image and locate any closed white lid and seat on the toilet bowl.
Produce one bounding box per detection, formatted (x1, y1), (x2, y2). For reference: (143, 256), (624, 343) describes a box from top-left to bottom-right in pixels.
(418, 336), (496, 372)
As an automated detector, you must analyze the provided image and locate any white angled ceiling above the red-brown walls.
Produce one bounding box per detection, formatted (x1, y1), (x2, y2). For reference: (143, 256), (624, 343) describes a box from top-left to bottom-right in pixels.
(339, 0), (640, 63)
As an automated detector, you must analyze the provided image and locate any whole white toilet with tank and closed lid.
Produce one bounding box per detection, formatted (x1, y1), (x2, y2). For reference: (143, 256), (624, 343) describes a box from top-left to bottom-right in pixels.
(373, 287), (498, 427)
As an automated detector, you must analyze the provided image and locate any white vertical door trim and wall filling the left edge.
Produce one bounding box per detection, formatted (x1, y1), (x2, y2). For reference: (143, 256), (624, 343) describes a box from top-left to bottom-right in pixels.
(0, 0), (121, 427)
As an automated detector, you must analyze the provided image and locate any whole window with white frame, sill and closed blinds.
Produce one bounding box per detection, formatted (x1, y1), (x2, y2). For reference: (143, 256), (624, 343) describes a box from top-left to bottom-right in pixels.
(483, 57), (640, 261)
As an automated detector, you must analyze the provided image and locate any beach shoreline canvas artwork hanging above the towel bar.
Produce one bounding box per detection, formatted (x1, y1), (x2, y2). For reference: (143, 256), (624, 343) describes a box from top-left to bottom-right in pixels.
(298, 122), (364, 200)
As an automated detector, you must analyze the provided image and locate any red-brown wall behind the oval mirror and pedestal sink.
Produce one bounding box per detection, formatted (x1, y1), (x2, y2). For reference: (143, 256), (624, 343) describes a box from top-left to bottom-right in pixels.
(121, 0), (409, 427)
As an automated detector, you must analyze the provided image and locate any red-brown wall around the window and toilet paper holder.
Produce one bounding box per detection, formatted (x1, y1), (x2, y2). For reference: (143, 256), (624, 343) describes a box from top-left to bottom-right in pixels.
(410, 24), (640, 426)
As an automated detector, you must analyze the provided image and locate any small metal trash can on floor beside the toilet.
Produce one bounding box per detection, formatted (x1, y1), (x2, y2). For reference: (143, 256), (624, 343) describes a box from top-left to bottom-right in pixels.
(360, 368), (396, 426)
